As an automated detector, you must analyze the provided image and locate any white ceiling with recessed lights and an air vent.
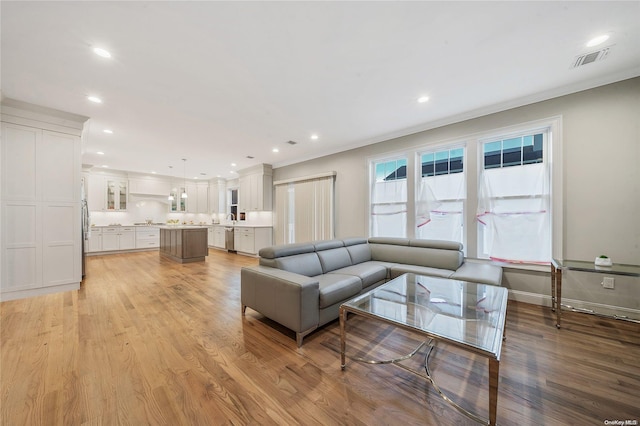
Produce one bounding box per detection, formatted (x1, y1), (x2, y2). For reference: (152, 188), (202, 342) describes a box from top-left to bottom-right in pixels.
(0, 0), (640, 179)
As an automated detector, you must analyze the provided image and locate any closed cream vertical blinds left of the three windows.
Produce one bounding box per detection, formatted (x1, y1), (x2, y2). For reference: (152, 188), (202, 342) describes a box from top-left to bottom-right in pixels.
(275, 174), (335, 244)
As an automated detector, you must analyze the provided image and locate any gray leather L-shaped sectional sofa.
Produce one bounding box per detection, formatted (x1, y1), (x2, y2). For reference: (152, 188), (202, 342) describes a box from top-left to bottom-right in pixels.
(241, 237), (502, 346)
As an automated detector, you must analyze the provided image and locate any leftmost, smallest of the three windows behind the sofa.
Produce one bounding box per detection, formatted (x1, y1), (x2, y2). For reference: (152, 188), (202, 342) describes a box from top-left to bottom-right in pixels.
(370, 158), (407, 237)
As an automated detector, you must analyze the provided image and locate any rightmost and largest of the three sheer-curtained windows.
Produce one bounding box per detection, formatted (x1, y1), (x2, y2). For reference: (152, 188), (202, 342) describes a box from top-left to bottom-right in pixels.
(477, 131), (551, 263)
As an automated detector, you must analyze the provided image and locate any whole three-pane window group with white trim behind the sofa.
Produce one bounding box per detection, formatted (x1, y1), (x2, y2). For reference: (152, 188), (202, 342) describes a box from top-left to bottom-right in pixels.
(369, 117), (563, 268)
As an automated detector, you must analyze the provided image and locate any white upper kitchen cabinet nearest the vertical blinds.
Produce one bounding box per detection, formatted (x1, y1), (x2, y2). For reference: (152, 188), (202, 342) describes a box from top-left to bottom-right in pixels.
(238, 164), (273, 212)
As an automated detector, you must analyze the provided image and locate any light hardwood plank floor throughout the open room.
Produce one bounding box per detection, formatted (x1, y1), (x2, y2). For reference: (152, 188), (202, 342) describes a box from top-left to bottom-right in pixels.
(0, 250), (640, 426)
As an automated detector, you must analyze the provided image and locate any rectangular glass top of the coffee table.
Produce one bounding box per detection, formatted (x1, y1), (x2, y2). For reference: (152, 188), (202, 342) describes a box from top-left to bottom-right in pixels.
(342, 274), (508, 359)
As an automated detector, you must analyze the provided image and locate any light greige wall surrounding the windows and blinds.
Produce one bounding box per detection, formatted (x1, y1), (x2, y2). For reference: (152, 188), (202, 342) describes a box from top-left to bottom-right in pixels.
(273, 78), (640, 307)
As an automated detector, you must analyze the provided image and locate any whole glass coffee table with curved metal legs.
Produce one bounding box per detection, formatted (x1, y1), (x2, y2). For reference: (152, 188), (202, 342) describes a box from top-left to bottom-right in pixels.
(340, 274), (508, 425)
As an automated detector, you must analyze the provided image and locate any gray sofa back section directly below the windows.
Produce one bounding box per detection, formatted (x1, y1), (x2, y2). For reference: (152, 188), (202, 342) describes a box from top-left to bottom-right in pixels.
(369, 237), (464, 271)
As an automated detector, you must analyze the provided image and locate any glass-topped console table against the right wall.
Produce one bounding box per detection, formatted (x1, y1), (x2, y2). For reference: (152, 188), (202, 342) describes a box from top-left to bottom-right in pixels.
(551, 259), (640, 328)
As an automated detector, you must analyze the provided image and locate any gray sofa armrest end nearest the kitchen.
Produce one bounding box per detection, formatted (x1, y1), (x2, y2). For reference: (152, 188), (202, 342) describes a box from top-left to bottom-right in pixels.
(240, 266), (320, 333)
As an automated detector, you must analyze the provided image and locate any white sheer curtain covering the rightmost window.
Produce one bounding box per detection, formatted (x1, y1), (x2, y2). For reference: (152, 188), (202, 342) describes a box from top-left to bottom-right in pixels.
(477, 163), (551, 263)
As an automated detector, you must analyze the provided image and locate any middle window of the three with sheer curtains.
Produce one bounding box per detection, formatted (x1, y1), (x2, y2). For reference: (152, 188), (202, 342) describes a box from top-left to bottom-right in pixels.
(415, 147), (466, 243)
